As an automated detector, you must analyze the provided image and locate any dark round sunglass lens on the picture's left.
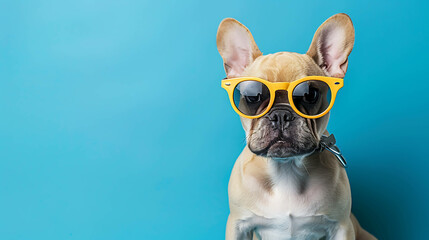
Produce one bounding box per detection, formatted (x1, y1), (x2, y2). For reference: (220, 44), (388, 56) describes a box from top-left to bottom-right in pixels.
(234, 80), (270, 116)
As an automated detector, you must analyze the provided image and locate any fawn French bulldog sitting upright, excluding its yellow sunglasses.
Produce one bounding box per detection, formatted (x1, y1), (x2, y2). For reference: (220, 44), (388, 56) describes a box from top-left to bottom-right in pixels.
(216, 13), (376, 240)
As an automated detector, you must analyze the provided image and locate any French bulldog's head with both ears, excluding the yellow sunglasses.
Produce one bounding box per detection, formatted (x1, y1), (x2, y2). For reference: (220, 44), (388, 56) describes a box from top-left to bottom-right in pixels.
(217, 14), (354, 160)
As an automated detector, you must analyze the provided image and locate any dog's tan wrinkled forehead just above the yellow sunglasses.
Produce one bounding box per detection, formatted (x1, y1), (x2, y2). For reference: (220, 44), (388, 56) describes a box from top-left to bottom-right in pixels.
(242, 52), (325, 82)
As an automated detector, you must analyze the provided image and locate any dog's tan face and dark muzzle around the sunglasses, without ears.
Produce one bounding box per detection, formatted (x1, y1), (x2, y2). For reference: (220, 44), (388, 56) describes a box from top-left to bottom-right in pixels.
(241, 52), (329, 159)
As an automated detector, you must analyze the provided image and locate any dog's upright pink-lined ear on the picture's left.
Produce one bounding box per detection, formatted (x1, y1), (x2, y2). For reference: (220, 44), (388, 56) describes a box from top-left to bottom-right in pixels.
(216, 18), (262, 78)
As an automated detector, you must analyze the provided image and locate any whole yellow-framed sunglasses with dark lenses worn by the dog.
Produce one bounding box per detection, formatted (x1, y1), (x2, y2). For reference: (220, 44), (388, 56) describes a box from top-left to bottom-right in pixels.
(222, 76), (343, 119)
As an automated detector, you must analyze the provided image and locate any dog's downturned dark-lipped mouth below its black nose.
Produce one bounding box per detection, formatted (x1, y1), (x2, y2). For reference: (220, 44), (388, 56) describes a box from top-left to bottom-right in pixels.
(249, 138), (318, 159)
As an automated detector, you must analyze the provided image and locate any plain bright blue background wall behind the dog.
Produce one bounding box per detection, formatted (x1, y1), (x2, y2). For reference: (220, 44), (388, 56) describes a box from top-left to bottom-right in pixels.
(0, 0), (429, 240)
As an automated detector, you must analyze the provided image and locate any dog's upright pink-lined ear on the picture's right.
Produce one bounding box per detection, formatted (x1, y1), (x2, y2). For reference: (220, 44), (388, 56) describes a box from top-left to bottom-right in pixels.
(307, 13), (355, 78)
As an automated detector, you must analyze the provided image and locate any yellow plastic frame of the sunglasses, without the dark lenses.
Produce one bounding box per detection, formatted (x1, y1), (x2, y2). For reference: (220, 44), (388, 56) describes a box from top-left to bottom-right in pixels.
(221, 76), (344, 119)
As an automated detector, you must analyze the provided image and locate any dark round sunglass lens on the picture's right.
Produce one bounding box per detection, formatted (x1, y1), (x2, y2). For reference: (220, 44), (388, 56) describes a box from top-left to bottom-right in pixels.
(292, 80), (332, 116)
